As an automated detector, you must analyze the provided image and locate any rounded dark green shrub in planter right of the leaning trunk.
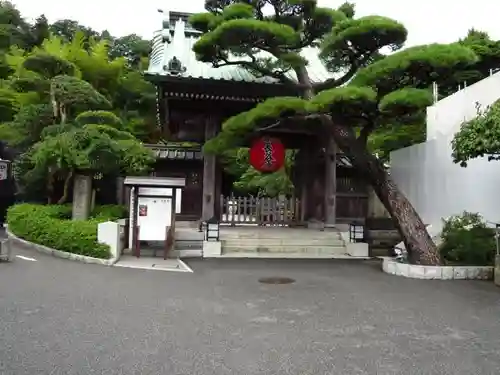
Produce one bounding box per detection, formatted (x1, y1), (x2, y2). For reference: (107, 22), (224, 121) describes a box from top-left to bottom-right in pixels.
(439, 212), (496, 266)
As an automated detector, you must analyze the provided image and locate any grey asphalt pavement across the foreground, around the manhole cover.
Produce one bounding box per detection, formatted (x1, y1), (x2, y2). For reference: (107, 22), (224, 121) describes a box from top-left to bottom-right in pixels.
(0, 242), (500, 375)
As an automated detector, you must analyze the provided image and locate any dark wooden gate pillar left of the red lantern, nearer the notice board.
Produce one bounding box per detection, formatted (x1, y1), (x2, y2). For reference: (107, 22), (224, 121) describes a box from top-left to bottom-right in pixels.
(201, 118), (217, 220)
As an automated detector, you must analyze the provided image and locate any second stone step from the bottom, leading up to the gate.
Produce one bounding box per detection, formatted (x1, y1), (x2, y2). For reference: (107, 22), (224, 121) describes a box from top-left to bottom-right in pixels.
(221, 238), (345, 247)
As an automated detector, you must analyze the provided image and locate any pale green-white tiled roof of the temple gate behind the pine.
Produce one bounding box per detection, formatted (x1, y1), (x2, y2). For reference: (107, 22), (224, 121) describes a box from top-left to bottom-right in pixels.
(146, 12), (334, 83)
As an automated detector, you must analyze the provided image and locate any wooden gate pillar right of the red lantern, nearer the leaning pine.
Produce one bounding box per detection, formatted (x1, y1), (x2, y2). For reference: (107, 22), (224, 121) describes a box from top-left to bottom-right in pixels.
(324, 138), (337, 227)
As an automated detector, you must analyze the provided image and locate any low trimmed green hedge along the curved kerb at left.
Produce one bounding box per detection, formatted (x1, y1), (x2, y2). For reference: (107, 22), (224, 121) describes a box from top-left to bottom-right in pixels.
(7, 203), (126, 259)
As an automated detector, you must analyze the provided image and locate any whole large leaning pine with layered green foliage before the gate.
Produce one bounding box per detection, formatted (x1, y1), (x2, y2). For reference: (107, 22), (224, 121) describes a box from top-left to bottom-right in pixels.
(190, 0), (477, 264)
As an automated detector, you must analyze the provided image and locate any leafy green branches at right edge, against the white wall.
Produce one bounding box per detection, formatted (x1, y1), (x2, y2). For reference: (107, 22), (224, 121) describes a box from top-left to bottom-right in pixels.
(451, 100), (500, 167)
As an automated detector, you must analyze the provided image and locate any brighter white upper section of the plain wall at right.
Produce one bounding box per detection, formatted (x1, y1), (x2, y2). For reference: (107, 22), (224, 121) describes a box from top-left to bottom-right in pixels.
(427, 72), (500, 140)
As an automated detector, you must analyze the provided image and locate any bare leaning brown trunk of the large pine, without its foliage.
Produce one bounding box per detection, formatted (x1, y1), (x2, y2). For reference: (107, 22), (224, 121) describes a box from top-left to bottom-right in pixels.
(322, 116), (440, 265)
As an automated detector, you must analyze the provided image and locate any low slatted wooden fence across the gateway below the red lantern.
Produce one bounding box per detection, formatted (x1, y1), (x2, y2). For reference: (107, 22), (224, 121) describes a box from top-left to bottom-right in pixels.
(220, 196), (300, 226)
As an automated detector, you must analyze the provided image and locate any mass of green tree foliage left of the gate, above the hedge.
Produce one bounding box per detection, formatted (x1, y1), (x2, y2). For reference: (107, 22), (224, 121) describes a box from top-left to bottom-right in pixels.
(0, 2), (155, 207)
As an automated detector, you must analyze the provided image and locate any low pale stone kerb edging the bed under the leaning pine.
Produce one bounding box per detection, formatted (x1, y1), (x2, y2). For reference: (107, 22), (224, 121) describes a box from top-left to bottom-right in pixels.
(382, 257), (493, 280)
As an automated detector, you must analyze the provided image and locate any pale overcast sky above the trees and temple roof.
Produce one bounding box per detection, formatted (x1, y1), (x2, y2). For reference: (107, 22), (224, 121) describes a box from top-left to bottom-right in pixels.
(11, 0), (500, 46)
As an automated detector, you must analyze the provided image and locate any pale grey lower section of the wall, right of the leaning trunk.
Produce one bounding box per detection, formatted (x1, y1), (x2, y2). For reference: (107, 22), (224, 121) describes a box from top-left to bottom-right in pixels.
(391, 134), (500, 231)
